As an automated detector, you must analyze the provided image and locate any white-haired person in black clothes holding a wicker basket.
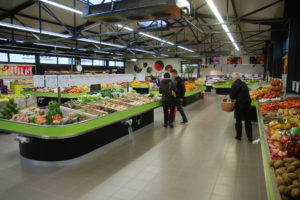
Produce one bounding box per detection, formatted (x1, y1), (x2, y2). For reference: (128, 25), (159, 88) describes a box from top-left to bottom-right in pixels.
(230, 72), (252, 142)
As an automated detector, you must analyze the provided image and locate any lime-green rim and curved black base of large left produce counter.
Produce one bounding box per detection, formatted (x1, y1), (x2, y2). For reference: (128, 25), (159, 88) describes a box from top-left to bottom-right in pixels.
(0, 101), (161, 161)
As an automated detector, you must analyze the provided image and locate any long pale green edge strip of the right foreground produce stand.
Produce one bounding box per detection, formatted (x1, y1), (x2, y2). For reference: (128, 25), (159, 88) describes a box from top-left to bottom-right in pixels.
(256, 103), (281, 200)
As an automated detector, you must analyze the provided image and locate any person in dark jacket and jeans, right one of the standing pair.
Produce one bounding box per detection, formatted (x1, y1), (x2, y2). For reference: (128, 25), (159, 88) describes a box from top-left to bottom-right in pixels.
(171, 69), (188, 124)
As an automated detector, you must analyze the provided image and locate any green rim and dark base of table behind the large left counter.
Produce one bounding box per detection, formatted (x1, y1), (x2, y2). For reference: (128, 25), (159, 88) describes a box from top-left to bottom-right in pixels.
(23, 92), (87, 106)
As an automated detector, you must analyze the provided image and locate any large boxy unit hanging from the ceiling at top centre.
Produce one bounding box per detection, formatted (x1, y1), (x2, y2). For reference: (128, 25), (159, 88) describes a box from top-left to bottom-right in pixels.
(82, 0), (190, 23)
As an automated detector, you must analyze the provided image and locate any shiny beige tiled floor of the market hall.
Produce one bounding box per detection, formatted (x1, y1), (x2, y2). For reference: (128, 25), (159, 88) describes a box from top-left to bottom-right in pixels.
(0, 94), (267, 200)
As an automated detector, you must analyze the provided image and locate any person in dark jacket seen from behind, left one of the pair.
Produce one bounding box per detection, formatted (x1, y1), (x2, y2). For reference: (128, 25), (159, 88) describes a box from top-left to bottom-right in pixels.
(159, 73), (176, 128)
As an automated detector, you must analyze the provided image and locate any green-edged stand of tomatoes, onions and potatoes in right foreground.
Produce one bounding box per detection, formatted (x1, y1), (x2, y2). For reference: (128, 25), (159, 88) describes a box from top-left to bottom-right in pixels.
(256, 97), (300, 200)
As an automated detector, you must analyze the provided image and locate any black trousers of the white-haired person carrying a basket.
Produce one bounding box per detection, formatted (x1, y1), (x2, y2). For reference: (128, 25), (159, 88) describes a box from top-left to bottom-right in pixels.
(235, 104), (252, 139)
